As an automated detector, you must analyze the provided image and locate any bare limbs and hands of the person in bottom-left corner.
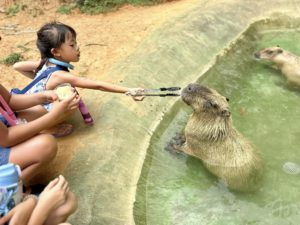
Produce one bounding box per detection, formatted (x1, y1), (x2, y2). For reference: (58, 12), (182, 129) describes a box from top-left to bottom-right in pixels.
(0, 176), (77, 225)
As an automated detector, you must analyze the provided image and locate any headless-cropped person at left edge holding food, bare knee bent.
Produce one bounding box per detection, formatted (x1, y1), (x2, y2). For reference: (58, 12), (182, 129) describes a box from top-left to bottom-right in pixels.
(0, 84), (80, 186)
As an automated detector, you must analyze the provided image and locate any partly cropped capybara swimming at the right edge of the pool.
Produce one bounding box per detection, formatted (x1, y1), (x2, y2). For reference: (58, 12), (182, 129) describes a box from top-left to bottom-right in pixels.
(254, 47), (300, 86)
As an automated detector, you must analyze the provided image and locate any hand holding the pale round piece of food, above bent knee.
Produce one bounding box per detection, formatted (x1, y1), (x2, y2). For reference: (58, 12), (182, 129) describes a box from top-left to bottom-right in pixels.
(50, 93), (80, 121)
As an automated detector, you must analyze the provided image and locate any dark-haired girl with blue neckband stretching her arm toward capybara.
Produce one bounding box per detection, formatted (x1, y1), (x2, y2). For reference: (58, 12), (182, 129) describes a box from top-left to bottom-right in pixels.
(14, 22), (143, 117)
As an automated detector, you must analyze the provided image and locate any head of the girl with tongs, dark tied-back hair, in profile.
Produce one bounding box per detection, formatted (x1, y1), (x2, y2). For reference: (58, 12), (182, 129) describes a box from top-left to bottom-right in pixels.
(36, 22), (80, 62)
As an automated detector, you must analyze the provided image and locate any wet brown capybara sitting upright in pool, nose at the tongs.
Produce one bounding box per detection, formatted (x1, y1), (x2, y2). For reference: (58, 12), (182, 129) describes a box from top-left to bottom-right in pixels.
(171, 84), (263, 192)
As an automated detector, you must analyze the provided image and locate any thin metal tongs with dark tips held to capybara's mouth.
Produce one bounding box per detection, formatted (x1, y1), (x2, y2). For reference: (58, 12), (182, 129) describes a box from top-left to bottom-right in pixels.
(126, 87), (181, 97)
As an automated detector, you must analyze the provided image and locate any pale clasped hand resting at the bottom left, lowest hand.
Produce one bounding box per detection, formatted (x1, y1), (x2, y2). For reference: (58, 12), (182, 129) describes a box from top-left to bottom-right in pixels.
(38, 175), (69, 211)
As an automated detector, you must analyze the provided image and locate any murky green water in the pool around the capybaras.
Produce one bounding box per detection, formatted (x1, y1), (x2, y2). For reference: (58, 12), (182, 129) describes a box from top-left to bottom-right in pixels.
(134, 20), (300, 225)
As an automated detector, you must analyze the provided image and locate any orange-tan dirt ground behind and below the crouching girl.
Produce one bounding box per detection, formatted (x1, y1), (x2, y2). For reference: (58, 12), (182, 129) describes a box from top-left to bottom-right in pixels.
(0, 0), (199, 177)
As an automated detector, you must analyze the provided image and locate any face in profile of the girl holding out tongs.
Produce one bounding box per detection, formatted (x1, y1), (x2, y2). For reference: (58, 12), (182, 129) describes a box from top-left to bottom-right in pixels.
(53, 33), (80, 63)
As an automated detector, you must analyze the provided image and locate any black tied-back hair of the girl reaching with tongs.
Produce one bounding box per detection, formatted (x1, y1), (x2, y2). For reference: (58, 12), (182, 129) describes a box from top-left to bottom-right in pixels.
(36, 21), (76, 72)
